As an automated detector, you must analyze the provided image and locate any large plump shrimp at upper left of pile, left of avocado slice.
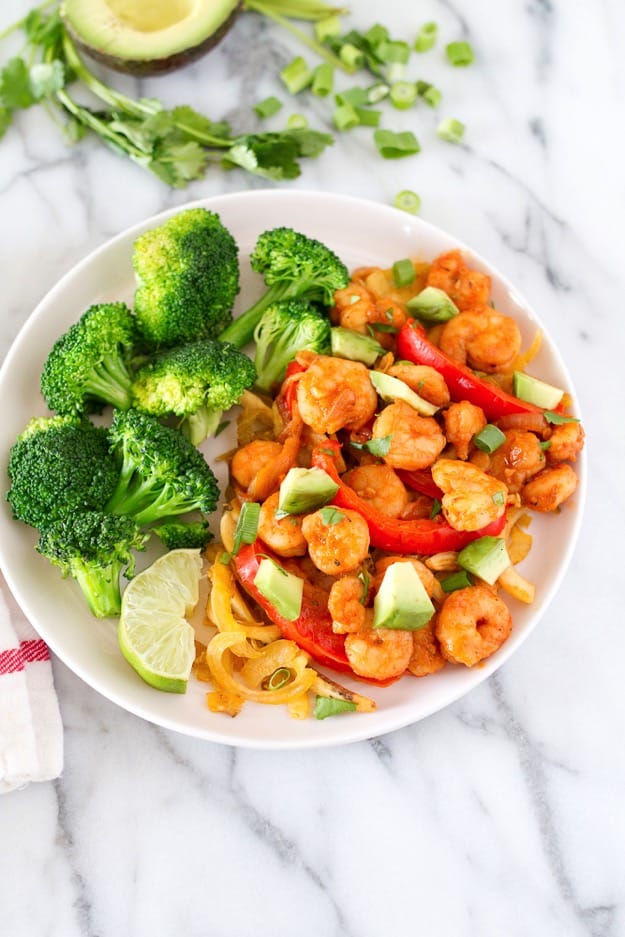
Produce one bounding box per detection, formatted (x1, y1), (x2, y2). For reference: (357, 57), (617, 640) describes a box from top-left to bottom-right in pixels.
(297, 355), (378, 433)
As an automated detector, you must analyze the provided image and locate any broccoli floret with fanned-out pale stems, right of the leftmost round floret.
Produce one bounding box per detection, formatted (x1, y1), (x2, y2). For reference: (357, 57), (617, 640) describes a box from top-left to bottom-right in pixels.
(105, 409), (219, 526)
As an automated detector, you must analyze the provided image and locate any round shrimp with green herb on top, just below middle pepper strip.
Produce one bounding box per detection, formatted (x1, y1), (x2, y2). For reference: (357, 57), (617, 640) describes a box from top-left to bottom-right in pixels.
(302, 508), (369, 576)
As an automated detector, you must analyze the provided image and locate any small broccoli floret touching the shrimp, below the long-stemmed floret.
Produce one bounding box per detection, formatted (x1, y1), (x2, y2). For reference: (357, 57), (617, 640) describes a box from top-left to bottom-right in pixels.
(254, 299), (331, 393)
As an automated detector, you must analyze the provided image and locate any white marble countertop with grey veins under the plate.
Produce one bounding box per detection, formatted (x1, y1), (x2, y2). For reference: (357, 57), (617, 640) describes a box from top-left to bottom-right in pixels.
(0, 0), (625, 937)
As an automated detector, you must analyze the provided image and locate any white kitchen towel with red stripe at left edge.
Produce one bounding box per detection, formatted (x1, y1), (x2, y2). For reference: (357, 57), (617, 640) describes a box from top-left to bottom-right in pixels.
(0, 576), (63, 794)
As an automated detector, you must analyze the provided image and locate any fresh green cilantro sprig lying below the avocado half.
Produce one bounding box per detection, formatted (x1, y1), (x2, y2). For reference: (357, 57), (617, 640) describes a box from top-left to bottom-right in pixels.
(0, 3), (333, 188)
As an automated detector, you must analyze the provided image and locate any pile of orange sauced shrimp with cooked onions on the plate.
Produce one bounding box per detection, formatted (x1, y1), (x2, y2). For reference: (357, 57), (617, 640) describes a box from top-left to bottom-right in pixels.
(193, 251), (584, 718)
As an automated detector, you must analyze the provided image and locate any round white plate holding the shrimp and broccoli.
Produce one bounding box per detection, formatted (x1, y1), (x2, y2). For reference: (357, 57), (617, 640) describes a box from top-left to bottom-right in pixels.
(0, 190), (584, 749)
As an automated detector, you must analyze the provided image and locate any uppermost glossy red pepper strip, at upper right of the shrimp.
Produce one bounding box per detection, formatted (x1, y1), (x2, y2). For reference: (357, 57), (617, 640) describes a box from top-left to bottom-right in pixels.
(397, 319), (543, 420)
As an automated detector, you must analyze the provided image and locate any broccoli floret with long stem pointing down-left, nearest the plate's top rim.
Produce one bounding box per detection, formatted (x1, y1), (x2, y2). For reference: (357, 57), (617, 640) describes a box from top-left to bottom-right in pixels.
(219, 228), (349, 348)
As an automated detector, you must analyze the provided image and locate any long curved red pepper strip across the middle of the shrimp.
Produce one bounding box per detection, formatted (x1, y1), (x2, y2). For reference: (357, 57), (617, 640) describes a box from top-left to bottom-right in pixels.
(312, 440), (506, 556)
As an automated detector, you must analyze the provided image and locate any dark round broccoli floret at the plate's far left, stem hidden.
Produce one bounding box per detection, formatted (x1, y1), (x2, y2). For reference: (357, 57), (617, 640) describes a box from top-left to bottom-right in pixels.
(7, 416), (119, 529)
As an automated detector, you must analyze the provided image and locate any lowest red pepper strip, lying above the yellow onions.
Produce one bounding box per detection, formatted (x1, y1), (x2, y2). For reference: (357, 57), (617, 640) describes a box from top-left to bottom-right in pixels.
(234, 542), (353, 675)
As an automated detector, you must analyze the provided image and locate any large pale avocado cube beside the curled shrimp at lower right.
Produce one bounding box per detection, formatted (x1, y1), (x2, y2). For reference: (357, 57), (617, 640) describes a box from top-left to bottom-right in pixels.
(373, 563), (434, 631)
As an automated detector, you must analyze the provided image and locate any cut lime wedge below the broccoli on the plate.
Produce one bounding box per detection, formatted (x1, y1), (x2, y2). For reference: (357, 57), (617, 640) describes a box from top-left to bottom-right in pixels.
(117, 550), (202, 693)
